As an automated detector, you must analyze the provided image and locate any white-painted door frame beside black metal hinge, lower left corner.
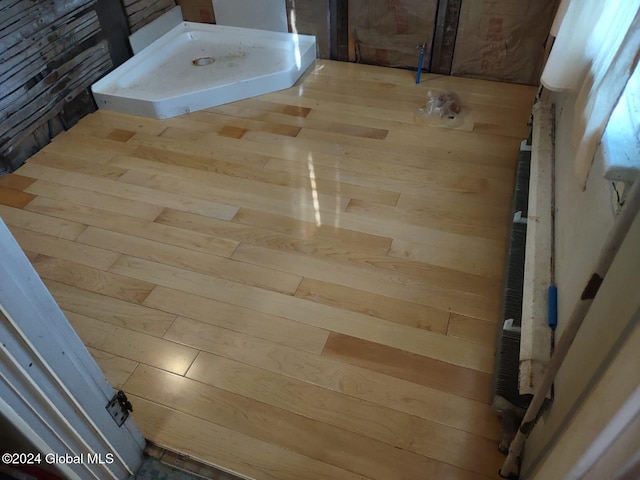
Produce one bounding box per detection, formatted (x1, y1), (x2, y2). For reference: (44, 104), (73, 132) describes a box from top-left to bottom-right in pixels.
(0, 219), (145, 480)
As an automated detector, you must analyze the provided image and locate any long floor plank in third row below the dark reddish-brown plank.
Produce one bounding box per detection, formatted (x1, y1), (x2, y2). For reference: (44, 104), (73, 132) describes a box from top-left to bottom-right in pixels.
(125, 366), (493, 480)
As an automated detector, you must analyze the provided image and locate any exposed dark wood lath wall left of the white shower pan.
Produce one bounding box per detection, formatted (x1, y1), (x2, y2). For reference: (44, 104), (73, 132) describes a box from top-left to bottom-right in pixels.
(0, 0), (112, 170)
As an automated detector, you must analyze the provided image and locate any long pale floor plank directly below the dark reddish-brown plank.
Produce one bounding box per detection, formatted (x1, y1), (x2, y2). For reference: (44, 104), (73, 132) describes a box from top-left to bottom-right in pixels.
(165, 317), (497, 435)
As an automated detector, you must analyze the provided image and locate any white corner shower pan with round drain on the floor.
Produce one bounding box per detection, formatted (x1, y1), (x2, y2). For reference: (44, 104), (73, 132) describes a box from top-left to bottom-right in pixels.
(91, 22), (316, 118)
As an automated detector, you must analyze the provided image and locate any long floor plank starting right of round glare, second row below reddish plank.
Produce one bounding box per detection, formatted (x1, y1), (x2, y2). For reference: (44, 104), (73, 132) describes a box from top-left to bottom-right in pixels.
(187, 352), (499, 478)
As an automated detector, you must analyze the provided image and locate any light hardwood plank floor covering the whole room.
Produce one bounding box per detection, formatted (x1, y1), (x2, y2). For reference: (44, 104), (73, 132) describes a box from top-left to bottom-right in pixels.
(0, 61), (535, 480)
